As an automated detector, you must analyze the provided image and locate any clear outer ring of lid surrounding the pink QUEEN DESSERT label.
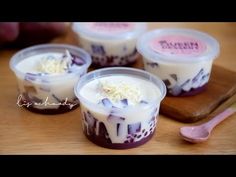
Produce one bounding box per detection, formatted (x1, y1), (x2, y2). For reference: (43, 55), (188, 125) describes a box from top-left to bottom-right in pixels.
(136, 28), (220, 64)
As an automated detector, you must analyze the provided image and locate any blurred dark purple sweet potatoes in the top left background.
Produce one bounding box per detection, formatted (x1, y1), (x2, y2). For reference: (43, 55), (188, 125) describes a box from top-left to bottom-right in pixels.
(0, 22), (68, 47)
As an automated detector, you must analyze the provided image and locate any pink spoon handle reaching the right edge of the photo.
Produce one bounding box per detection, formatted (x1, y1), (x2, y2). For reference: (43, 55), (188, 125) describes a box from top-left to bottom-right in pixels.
(205, 108), (236, 130)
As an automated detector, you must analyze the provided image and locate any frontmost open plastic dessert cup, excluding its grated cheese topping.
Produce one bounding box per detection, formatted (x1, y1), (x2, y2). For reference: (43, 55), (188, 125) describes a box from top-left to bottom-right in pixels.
(75, 67), (166, 149)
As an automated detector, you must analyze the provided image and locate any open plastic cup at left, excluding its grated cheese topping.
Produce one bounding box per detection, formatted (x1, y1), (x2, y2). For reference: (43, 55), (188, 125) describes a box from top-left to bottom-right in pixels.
(10, 44), (91, 114)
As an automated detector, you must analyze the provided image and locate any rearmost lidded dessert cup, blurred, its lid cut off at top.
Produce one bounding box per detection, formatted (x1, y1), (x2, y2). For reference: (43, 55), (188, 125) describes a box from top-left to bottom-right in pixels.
(73, 22), (147, 67)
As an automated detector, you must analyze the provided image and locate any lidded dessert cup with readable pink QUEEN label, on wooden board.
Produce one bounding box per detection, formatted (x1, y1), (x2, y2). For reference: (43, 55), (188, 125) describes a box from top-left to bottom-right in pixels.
(137, 29), (219, 96)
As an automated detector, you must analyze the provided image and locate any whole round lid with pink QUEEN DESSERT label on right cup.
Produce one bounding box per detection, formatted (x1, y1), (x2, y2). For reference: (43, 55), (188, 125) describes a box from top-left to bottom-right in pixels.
(137, 28), (220, 63)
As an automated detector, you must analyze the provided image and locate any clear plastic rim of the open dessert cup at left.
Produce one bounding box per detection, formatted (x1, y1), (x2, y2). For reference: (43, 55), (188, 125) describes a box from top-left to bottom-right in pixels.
(9, 44), (92, 81)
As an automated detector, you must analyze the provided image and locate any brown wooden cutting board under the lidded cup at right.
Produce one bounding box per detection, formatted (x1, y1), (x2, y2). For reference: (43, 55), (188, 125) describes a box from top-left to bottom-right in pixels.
(160, 65), (236, 123)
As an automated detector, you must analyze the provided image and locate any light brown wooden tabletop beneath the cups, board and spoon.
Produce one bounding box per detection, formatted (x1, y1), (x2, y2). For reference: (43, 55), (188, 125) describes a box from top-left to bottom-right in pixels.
(0, 23), (236, 154)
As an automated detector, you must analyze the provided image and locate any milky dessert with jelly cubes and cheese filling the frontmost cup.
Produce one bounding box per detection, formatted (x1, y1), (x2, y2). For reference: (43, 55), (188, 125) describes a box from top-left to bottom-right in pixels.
(79, 75), (162, 143)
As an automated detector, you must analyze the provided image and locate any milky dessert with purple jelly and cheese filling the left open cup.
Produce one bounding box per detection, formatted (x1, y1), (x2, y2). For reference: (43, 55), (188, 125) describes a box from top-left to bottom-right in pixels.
(12, 46), (91, 114)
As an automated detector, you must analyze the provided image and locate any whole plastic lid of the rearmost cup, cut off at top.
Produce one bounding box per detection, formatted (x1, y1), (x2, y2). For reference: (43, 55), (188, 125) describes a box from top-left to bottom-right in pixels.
(72, 22), (147, 40)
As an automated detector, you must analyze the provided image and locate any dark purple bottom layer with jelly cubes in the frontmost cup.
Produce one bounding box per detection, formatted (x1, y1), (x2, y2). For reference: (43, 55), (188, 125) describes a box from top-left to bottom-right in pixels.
(82, 111), (156, 149)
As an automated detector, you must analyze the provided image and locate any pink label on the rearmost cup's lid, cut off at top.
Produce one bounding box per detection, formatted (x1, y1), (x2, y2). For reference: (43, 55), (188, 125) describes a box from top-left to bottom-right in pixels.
(86, 22), (135, 34)
